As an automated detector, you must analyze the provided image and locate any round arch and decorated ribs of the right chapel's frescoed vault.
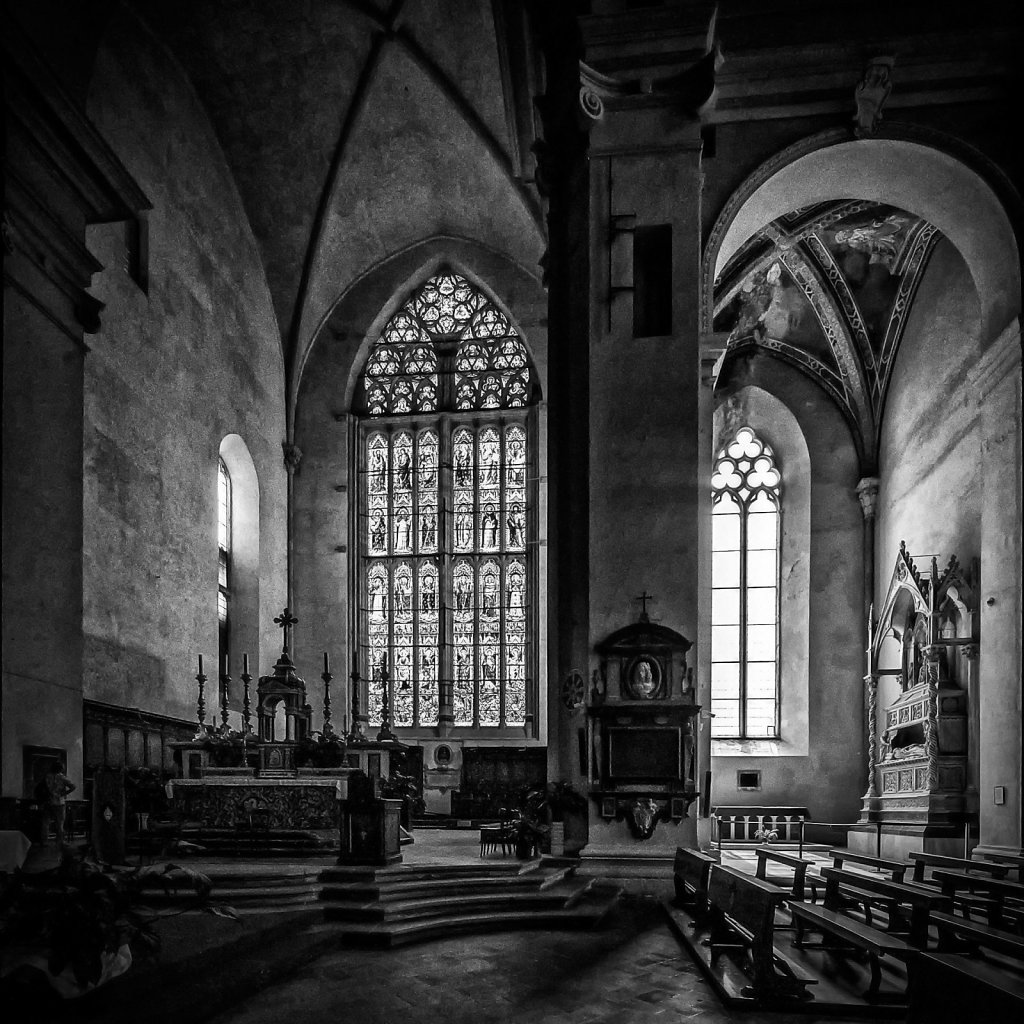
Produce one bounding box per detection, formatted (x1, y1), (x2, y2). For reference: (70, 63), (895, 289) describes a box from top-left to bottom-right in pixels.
(701, 125), (1020, 469)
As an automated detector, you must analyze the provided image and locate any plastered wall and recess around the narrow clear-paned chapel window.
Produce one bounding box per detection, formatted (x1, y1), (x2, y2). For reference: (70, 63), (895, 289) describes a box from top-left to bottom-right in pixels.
(712, 356), (866, 822)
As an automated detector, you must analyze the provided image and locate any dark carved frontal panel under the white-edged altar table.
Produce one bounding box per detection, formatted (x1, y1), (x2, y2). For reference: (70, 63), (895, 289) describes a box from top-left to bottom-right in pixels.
(171, 772), (348, 831)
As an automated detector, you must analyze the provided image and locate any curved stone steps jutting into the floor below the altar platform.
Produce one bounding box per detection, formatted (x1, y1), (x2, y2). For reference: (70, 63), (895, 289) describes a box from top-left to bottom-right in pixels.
(322, 861), (620, 948)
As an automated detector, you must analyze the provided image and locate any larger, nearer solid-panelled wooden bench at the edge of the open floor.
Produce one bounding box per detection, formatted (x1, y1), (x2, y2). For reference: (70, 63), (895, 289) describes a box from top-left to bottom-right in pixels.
(707, 864), (816, 999)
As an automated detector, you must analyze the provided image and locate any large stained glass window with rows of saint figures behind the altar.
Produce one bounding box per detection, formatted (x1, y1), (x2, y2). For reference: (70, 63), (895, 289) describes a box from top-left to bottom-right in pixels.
(359, 272), (535, 729)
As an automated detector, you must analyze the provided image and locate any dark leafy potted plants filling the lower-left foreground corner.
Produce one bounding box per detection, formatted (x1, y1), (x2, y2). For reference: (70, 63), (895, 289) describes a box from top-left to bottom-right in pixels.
(0, 851), (236, 1005)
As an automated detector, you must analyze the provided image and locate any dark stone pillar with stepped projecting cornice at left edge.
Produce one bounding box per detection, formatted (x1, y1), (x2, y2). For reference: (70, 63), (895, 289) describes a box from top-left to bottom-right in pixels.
(0, 19), (150, 797)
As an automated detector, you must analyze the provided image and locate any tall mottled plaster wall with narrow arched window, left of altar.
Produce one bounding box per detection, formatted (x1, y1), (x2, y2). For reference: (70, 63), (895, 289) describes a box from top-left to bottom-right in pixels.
(83, 13), (286, 719)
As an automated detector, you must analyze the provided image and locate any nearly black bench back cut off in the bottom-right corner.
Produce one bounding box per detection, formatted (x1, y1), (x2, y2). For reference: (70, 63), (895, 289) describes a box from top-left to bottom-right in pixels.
(906, 953), (1024, 1024)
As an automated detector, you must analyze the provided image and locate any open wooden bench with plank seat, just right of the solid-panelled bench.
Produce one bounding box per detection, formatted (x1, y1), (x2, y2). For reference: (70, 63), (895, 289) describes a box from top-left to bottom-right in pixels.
(790, 867), (930, 1000)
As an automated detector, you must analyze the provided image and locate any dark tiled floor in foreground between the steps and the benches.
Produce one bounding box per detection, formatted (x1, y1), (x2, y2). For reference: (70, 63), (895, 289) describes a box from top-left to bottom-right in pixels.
(214, 898), (864, 1024)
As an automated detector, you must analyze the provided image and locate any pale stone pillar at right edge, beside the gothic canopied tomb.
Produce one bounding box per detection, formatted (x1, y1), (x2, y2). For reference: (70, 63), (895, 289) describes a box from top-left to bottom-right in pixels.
(972, 322), (1024, 855)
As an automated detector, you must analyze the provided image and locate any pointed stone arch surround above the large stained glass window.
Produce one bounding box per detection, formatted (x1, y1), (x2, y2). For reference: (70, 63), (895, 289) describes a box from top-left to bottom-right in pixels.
(291, 237), (547, 417)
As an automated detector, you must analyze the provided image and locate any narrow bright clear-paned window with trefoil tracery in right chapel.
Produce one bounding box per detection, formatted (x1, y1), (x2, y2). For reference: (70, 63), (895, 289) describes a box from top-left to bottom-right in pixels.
(711, 427), (781, 738)
